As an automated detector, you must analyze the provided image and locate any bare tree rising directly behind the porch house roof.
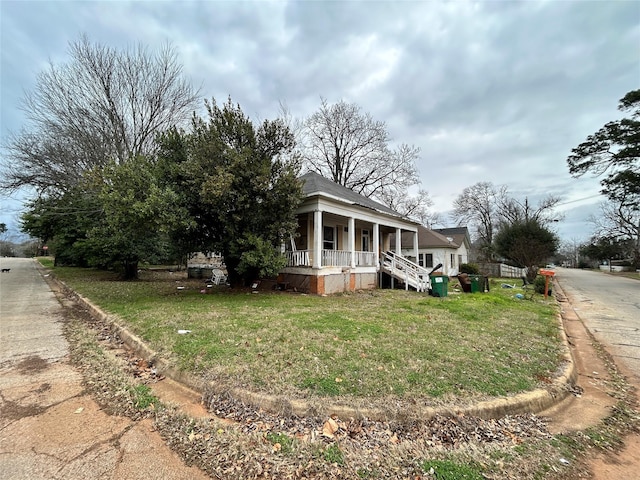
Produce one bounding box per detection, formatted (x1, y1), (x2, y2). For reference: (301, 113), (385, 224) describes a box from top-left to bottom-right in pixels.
(299, 98), (429, 213)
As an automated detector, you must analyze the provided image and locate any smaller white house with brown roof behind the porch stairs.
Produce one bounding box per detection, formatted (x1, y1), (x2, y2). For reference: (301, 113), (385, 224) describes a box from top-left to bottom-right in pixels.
(392, 226), (471, 277)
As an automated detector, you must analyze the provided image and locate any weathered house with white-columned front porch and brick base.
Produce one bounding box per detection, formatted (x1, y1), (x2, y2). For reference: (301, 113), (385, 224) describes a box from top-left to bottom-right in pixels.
(278, 172), (420, 294)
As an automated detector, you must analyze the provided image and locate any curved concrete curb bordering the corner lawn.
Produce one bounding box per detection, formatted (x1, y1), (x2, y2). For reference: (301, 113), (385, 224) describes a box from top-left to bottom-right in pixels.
(47, 268), (578, 421)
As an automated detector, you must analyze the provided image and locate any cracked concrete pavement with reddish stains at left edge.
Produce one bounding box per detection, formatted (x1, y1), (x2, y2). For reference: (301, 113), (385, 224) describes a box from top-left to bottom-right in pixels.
(0, 258), (208, 480)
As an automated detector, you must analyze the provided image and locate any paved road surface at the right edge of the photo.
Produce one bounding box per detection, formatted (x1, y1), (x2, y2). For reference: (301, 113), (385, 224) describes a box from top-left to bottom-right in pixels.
(556, 268), (640, 385)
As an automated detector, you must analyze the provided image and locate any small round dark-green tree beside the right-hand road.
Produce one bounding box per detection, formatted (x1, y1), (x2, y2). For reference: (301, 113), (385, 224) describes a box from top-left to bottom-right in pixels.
(495, 220), (559, 280)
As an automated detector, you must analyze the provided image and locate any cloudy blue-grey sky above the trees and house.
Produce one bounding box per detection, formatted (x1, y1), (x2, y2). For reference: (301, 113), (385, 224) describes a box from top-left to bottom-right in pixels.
(0, 0), (640, 241)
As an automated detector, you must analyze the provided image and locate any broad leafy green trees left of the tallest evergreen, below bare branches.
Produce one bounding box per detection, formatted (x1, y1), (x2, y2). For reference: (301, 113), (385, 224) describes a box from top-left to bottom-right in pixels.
(21, 156), (190, 279)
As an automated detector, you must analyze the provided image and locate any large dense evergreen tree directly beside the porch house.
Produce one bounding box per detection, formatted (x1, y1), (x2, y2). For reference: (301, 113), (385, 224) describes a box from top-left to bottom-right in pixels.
(159, 99), (302, 284)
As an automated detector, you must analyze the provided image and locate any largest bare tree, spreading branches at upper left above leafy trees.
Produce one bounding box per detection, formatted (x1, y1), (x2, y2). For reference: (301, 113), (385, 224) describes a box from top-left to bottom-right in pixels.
(0, 36), (198, 192)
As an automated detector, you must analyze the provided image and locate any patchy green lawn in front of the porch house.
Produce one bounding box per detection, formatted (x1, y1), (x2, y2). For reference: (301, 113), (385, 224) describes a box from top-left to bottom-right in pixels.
(47, 268), (561, 404)
